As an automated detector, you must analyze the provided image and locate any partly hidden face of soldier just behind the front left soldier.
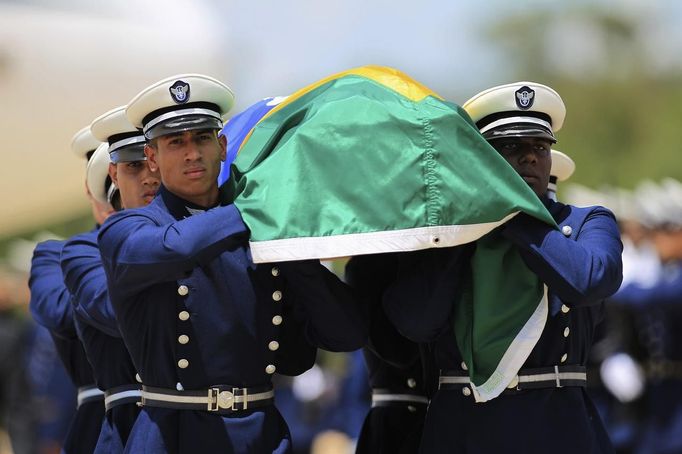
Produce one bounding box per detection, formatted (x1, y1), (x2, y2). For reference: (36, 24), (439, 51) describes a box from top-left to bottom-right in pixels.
(109, 161), (161, 208)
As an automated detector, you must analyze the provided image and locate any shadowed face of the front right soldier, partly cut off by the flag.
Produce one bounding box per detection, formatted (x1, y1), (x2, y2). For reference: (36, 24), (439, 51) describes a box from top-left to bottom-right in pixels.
(490, 137), (552, 197)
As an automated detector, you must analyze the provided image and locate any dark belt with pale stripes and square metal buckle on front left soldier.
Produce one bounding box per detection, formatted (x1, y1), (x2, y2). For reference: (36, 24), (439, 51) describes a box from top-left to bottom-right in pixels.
(141, 385), (275, 414)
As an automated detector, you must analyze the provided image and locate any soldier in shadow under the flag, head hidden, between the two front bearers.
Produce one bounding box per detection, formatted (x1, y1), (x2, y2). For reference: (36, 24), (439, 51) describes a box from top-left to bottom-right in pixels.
(346, 254), (430, 454)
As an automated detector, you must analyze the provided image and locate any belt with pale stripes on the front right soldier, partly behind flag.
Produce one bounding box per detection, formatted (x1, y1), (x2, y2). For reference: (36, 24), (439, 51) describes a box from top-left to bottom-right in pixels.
(438, 366), (587, 393)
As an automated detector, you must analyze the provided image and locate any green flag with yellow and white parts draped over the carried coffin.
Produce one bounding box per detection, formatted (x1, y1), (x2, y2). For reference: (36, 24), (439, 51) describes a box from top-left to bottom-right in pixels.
(228, 66), (554, 400)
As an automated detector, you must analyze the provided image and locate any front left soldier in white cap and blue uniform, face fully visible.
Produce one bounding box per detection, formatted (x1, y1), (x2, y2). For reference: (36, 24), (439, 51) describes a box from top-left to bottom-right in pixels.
(99, 74), (367, 453)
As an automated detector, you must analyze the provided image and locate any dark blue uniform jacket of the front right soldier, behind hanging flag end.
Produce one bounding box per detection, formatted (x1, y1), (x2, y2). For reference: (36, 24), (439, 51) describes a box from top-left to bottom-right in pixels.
(384, 201), (622, 454)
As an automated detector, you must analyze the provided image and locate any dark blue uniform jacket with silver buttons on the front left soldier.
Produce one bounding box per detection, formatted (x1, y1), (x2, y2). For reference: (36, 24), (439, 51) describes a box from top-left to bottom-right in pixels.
(99, 187), (367, 453)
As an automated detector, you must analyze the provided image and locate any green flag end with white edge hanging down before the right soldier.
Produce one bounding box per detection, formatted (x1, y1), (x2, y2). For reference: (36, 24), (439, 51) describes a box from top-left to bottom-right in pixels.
(454, 231), (548, 402)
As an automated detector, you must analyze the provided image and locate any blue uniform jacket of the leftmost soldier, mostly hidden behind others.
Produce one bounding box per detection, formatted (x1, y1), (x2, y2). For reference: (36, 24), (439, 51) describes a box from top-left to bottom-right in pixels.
(28, 240), (104, 454)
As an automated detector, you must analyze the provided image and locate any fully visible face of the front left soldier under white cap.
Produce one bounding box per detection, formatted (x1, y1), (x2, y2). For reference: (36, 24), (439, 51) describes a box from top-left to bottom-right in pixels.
(145, 130), (227, 206)
